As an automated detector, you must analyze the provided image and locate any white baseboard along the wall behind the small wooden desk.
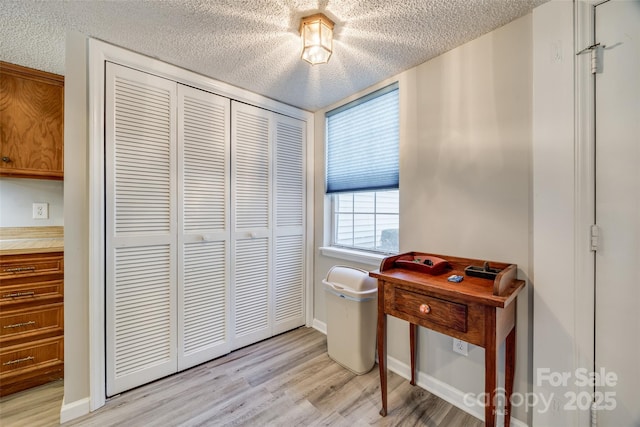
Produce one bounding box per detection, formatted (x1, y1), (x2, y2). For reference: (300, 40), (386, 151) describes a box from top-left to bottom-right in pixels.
(387, 356), (527, 427)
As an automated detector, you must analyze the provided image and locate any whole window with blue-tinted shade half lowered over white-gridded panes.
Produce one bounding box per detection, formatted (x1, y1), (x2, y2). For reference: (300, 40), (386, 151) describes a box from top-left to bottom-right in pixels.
(326, 83), (400, 253)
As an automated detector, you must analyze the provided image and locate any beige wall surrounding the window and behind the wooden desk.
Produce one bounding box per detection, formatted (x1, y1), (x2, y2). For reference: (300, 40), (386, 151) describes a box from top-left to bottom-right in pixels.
(315, 15), (533, 422)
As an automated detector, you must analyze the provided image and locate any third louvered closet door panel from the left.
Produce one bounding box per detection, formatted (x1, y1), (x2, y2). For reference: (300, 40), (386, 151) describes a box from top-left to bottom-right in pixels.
(231, 101), (272, 349)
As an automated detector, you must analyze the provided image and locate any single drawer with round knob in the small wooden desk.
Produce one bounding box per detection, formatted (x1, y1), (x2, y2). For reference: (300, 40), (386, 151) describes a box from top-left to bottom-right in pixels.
(391, 288), (467, 332)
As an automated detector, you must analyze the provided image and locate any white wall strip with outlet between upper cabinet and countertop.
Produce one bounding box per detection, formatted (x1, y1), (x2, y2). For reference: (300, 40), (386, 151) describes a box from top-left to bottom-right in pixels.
(0, 178), (64, 227)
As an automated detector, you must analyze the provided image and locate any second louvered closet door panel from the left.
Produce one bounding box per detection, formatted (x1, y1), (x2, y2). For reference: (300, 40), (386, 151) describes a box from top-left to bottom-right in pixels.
(178, 85), (231, 370)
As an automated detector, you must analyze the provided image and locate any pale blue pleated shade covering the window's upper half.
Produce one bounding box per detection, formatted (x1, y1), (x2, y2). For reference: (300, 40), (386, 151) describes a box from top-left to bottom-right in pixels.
(326, 83), (399, 193)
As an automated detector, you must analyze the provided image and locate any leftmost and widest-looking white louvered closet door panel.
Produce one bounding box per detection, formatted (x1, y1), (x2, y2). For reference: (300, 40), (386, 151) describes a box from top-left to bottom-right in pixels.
(105, 63), (177, 396)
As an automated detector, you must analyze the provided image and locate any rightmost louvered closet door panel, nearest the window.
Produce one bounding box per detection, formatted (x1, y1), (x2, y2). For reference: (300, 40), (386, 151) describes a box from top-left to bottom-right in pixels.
(272, 114), (306, 335)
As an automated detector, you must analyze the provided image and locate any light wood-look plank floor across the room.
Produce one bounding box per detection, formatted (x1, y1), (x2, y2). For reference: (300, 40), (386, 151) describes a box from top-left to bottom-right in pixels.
(0, 328), (483, 427)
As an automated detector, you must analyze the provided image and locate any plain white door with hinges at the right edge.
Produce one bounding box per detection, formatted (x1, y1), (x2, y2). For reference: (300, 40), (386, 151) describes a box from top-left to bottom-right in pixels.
(595, 0), (640, 426)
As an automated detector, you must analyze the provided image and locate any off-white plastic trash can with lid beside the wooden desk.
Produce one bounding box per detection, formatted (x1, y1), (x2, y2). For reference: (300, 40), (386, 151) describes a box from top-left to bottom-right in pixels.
(322, 265), (378, 375)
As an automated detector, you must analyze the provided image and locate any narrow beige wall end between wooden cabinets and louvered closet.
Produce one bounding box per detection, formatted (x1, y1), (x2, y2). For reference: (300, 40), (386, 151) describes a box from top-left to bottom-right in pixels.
(60, 33), (90, 422)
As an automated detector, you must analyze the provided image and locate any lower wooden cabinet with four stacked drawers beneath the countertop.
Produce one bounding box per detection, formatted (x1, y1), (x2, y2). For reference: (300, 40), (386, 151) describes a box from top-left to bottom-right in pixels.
(0, 252), (64, 396)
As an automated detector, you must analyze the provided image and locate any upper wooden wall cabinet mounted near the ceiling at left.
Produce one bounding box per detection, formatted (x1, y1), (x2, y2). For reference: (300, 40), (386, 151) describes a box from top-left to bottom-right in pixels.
(0, 61), (64, 179)
